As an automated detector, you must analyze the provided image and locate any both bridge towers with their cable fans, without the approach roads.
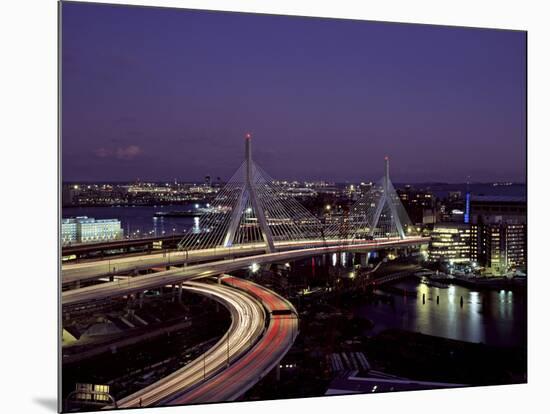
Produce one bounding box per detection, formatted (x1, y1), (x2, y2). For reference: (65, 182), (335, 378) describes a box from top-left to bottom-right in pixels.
(178, 134), (414, 253)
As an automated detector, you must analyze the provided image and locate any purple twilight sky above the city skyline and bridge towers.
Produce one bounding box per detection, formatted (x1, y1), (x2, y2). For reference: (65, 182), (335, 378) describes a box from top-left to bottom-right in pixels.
(62, 2), (526, 182)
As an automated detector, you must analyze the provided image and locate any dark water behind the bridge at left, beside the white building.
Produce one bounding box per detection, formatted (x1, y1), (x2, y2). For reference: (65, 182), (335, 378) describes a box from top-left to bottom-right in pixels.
(63, 204), (198, 237)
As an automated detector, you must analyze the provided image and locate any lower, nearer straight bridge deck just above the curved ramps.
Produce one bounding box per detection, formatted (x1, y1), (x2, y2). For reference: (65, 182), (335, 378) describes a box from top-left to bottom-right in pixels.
(61, 237), (429, 308)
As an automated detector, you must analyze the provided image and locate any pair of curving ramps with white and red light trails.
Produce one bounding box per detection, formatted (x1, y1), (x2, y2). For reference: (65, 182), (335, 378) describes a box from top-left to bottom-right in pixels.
(113, 276), (298, 408)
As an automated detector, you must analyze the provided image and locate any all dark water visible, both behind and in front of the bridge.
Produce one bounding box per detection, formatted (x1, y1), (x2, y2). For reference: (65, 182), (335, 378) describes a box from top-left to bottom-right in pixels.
(63, 204), (527, 346)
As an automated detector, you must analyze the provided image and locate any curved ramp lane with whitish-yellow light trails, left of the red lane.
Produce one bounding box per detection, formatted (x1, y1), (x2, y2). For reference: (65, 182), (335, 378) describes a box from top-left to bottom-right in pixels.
(117, 282), (266, 408)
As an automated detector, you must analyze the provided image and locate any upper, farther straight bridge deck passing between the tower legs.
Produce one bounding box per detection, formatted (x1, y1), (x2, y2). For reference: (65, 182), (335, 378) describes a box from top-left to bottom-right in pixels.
(61, 237), (428, 285)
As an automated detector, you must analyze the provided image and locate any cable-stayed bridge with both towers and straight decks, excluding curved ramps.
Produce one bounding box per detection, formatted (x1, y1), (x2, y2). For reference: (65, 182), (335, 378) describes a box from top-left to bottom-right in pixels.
(62, 134), (428, 292)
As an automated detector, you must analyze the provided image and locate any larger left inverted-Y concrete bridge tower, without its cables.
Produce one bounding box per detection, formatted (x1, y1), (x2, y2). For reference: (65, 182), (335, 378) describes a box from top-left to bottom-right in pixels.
(223, 133), (275, 253)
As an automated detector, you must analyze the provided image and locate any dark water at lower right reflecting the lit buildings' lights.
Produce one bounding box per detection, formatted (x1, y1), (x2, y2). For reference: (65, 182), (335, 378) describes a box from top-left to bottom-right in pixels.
(358, 281), (527, 346)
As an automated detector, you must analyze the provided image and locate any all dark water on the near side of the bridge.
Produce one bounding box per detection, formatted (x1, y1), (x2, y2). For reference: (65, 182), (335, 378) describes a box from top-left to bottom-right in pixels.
(292, 254), (527, 347)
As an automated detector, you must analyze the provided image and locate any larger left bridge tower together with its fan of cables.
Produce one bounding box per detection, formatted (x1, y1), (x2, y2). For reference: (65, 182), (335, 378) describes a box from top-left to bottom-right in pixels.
(178, 133), (323, 253)
